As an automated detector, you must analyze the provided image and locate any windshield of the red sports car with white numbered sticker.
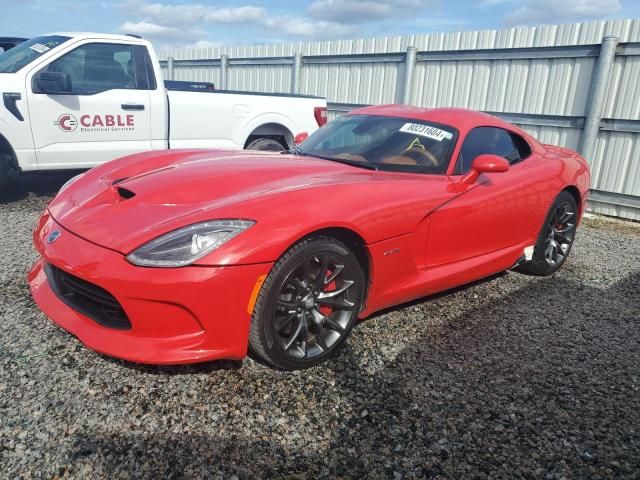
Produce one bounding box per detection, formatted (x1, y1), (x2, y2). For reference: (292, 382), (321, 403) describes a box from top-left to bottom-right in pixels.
(296, 115), (458, 174)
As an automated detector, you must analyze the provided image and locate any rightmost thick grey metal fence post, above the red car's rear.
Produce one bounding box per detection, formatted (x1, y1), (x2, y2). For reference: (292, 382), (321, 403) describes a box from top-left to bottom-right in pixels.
(580, 36), (618, 160)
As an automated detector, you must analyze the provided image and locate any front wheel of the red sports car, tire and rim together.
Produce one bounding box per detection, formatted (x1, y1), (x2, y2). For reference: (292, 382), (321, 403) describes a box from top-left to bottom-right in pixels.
(249, 236), (365, 370)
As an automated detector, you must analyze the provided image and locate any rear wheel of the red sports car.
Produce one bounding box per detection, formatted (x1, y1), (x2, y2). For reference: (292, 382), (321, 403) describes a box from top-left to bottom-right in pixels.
(519, 191), (578, 276)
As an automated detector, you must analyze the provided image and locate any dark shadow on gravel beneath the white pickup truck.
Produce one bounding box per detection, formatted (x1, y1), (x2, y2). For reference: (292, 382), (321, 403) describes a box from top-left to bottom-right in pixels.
(0, 170), (86, 205)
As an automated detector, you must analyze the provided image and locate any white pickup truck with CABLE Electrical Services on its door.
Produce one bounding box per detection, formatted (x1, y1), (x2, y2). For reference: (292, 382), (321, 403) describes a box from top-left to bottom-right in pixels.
(0, 33), (327, 190)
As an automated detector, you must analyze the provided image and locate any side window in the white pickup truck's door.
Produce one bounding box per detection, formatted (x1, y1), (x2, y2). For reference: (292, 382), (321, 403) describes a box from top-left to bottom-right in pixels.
(47, 43), (149, 95)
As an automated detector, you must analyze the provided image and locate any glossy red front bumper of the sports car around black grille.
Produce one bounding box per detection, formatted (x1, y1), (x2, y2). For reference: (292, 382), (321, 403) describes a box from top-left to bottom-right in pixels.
(28, 212), (272, 364)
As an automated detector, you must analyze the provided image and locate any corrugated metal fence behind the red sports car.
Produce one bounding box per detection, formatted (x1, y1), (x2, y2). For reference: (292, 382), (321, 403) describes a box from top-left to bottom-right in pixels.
(160, 20), (640, 220)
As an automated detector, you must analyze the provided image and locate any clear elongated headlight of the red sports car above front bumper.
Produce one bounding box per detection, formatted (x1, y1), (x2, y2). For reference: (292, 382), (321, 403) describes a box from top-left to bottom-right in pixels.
(127, 220), (256, 267)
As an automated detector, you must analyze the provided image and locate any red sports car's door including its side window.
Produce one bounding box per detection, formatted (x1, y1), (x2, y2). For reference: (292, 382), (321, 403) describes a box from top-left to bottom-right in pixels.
(427, 127), (544, 266)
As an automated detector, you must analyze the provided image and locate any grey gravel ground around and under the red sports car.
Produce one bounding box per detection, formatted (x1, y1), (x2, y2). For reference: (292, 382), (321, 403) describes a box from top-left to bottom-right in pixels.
(0, 175), (640, 479)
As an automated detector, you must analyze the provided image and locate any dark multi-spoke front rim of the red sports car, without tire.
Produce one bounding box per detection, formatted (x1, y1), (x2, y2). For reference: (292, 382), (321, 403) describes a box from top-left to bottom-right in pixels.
(272, 253), (359, 360)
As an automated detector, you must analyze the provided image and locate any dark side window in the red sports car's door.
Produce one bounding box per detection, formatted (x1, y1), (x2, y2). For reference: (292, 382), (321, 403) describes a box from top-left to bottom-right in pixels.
(455, 127), (531, 174)
